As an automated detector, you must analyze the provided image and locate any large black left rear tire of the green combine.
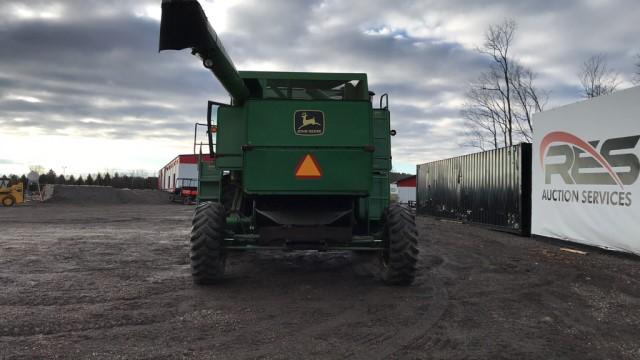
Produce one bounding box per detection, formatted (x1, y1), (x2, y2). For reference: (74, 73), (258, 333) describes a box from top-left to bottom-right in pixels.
(190, 202), (226, 284)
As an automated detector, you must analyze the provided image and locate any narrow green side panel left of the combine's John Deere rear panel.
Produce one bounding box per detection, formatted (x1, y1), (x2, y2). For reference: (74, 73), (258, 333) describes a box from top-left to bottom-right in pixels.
(216, 106), (247, 170)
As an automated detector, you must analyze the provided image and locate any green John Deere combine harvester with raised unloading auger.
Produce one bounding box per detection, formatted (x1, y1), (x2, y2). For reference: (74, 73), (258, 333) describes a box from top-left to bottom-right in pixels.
(160, 0), (418, 285)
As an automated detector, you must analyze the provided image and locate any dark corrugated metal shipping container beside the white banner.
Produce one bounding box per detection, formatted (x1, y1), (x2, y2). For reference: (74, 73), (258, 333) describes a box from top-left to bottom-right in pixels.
(417, 143), (531, 236)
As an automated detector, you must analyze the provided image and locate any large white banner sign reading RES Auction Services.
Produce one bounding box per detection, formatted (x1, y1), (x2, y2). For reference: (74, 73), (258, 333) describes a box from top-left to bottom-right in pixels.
(531, 87), (640, 255)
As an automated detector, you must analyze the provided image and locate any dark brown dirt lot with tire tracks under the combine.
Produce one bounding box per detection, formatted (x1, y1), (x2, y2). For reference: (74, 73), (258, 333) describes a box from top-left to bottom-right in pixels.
(0, 204), (640, 359)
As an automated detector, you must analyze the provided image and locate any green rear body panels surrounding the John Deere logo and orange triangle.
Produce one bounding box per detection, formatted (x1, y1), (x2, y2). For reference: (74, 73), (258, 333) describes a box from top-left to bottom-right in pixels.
(243, 100), (373, 195)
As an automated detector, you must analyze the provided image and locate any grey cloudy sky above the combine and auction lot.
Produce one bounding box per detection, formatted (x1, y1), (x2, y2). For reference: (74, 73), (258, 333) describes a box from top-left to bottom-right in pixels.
(0, 0), (640, 174)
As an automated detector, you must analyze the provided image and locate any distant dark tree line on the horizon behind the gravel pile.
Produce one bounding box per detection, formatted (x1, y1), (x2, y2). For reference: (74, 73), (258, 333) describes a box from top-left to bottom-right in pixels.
(1, 169), (158, 189)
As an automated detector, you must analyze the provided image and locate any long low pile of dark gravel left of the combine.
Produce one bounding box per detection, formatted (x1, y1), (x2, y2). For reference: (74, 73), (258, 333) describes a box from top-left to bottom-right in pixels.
(47, 185), (170, 205)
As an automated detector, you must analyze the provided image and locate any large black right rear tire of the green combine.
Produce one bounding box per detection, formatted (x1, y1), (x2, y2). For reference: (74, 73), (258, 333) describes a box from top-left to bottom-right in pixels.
(381, 204), (418, 286)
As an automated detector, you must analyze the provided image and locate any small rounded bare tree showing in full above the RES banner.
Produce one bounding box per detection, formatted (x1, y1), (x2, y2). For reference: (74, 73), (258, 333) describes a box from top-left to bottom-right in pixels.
(578, 54), (620, 98)
